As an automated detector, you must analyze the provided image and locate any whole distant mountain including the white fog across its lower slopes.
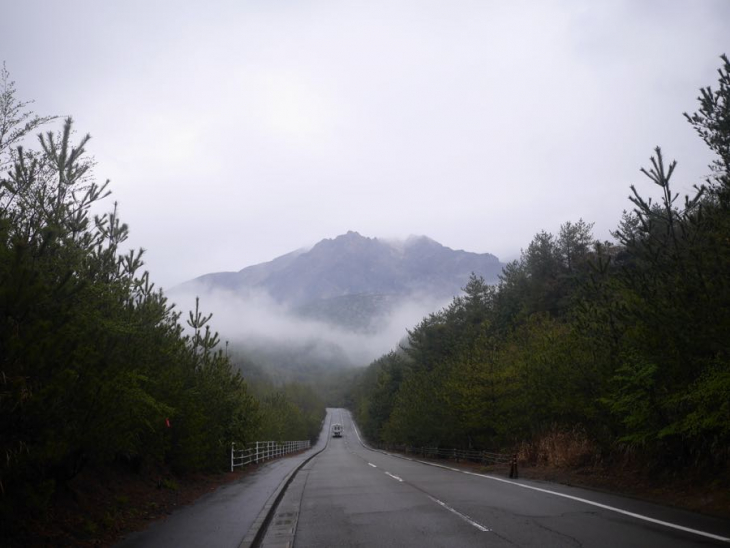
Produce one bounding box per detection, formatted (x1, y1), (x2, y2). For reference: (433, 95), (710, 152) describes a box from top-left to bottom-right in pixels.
(168, 231), (503, 384)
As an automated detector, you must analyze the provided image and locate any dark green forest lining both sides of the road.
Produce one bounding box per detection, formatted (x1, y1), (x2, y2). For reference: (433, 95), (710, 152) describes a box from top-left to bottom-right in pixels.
(0, 51), (730, 540)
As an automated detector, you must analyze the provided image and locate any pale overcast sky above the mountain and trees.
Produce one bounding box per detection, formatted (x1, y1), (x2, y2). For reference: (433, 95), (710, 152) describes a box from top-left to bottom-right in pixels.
(0, 0), (730, 287)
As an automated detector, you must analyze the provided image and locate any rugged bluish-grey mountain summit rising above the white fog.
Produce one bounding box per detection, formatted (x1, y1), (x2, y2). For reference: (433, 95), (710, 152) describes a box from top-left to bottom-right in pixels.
(179, 230), (503, 307)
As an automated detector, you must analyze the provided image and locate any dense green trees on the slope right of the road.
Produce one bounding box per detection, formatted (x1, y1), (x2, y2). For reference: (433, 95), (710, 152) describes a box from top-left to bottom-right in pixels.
(351, 56), (730, 467)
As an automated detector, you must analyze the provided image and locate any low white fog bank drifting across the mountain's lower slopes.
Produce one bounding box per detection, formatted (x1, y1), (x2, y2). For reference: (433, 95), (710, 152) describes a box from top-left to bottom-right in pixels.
(168, 286), (451, 367)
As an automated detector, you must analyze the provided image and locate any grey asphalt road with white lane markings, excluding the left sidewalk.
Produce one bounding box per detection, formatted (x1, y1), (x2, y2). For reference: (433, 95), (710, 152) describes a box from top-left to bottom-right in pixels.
(272, 409), (730, 548)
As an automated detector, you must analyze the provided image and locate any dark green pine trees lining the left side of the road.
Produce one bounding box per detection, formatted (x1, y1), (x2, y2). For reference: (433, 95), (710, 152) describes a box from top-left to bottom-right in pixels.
(0, 68), (324, 529)
